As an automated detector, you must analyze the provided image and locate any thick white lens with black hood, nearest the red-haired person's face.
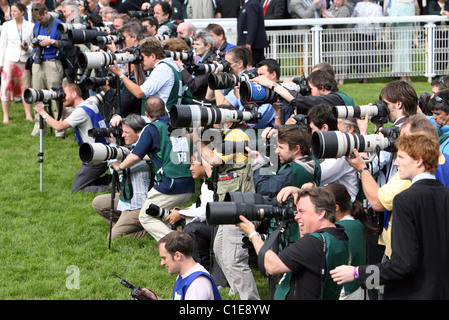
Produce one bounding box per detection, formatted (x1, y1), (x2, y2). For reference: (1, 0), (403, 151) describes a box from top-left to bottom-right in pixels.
(312, 131), (396, 159)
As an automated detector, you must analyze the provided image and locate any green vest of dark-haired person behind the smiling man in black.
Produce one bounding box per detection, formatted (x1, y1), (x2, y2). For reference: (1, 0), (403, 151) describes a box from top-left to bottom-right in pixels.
(336, 220), (366, 295)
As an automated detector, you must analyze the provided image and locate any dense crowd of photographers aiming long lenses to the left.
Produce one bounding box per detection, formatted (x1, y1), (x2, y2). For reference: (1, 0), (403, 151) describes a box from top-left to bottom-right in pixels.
(7, 0), (449, 300)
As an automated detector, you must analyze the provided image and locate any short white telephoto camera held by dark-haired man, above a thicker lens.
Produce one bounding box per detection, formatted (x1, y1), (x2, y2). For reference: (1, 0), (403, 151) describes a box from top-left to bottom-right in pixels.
(332, 100), (388, 124)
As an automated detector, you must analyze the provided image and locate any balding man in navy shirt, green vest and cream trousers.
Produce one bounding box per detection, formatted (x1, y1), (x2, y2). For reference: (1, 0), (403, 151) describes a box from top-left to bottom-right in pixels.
(109, 97), (195, 240)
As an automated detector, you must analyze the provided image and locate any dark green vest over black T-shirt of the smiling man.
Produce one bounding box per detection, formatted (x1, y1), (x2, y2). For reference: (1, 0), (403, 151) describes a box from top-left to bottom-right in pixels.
(274, 232), (349, 300)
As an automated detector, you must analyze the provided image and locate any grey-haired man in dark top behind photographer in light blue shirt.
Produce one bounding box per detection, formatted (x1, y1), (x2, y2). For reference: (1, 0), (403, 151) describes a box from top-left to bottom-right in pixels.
(175, 31), (214, 103)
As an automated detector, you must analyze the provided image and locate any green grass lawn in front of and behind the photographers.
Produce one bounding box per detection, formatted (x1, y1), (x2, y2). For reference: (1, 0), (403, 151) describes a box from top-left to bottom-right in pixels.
(0, 77), (431, 300)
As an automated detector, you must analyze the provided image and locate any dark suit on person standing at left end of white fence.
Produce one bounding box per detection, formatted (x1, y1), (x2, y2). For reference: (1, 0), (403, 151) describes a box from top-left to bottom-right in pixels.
(237, 0), (269, 49)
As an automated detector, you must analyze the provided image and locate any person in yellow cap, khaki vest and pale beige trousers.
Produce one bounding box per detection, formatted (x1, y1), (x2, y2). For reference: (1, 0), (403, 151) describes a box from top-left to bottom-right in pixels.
(193, 105), (260, 300)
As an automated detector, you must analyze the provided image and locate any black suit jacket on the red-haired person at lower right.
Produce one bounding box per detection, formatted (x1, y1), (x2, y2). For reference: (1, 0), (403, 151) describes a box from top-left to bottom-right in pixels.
(359, 179), (449, 300)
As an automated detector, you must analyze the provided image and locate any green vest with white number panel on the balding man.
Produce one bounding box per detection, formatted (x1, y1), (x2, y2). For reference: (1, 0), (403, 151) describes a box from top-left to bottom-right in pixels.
(149, 120), (192, 181)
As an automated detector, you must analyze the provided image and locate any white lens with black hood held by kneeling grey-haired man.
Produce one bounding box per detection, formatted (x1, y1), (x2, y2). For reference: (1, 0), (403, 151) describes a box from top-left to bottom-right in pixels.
(79, 142), (131, 163)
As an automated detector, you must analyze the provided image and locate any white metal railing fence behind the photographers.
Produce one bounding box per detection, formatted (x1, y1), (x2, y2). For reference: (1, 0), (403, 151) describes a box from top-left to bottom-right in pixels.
(190, 16), (449, 79)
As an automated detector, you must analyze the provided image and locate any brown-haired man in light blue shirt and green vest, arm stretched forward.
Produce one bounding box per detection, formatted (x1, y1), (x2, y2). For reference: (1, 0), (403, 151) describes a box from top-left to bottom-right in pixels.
(107, 38), (182, 111)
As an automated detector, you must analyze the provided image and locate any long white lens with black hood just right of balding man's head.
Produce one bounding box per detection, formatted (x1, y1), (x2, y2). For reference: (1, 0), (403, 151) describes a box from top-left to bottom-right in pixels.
(170, 105), (260, 128)
